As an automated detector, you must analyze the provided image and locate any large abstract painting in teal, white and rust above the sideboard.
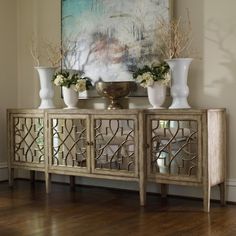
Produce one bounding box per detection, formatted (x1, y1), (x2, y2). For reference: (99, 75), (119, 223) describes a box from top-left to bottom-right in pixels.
(61, 0), (171, 96)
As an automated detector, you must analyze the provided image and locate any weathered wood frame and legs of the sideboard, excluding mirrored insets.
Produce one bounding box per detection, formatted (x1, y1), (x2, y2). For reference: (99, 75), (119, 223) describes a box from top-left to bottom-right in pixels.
(7, 109), (226, 212)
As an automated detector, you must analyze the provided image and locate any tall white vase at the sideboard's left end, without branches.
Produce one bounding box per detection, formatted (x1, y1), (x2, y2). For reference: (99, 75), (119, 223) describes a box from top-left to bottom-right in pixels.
(35, 66), (56, 109)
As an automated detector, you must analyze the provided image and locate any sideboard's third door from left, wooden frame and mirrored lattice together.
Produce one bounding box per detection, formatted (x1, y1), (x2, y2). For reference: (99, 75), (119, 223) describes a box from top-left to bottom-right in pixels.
(92, 115), (138, 176)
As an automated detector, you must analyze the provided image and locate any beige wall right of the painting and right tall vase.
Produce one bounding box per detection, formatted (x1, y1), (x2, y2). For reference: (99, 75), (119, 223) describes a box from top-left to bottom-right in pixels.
(175, 0), (236, 180)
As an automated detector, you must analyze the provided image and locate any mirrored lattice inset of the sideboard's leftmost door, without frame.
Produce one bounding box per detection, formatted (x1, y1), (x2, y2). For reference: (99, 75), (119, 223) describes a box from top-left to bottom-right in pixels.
(13, 117), (44, 164)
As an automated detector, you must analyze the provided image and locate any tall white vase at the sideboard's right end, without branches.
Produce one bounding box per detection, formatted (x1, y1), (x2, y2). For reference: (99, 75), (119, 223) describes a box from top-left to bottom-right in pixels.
(166, 58), (193, 109)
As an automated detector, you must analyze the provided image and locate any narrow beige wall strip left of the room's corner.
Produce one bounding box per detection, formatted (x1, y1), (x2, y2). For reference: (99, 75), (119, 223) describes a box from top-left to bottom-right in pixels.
(0, 0), (17, 164)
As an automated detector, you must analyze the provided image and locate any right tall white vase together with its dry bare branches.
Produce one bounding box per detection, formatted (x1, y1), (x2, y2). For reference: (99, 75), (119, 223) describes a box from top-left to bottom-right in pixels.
(153, 10), (195, 109)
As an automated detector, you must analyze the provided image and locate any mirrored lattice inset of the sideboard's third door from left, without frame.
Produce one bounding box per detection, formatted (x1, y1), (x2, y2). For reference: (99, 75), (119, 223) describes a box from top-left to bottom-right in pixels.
(94, 119), (135, 172)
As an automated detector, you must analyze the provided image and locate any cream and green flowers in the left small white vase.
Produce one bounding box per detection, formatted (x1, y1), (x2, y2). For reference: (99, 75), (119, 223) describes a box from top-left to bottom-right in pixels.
(53, 70), (92, 92)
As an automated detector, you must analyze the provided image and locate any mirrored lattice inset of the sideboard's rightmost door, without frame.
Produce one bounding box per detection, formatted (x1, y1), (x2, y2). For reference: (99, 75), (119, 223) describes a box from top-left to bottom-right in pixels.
(150, 120), (199, 176)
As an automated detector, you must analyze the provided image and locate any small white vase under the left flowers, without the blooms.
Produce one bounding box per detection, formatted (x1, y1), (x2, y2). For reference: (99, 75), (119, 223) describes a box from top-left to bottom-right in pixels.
(62, 86), (78, 109)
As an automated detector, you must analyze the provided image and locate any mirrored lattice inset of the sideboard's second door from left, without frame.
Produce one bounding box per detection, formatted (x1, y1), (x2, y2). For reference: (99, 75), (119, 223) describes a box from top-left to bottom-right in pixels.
(50, 118), (87, 167)
